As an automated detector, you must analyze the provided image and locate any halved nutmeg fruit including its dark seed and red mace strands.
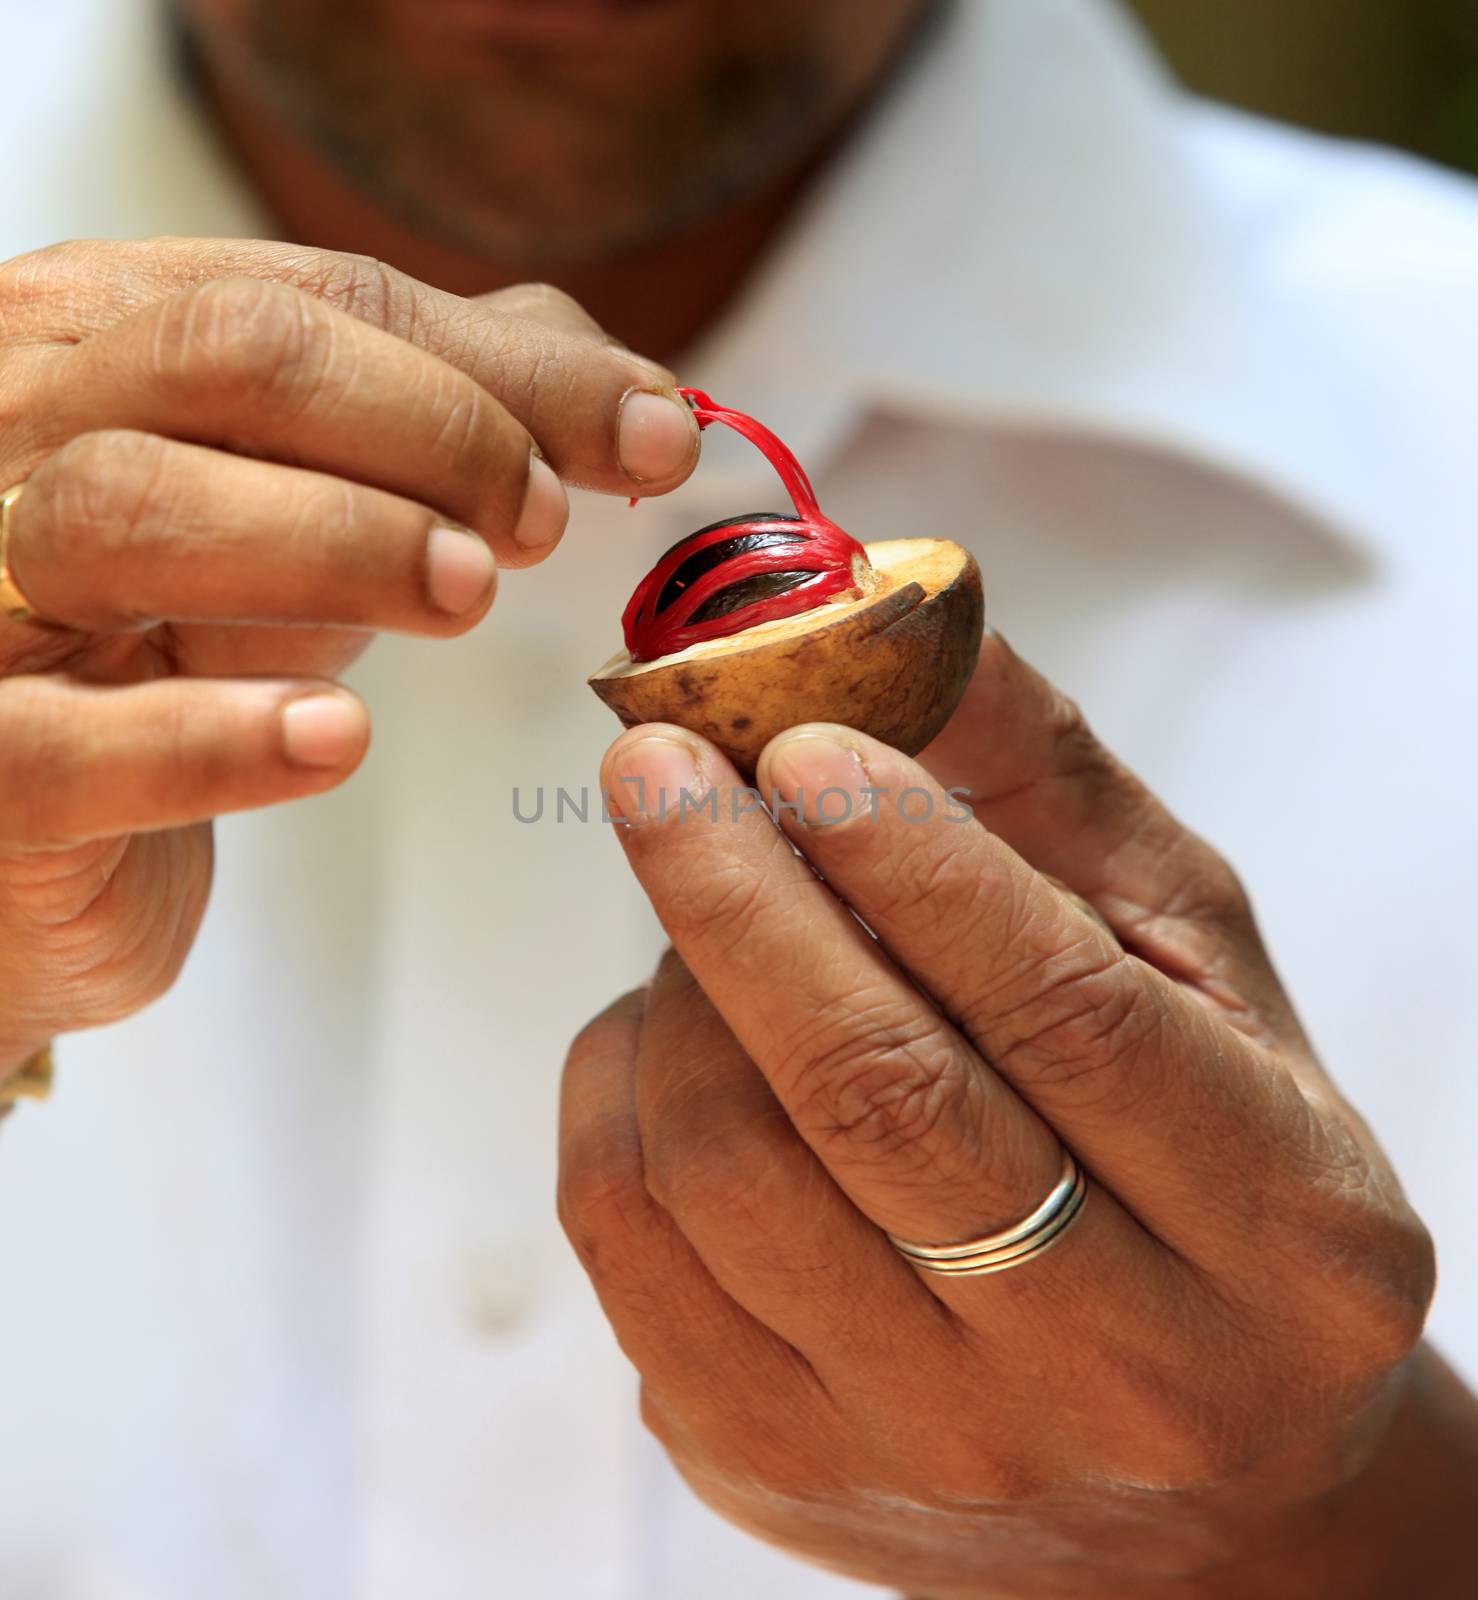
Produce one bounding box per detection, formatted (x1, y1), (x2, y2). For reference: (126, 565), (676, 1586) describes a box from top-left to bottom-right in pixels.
(590, 380), (984, 776)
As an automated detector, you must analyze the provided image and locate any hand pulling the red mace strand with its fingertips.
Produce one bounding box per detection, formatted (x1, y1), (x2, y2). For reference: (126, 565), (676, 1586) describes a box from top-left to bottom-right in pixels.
(0, 240), (697, 1074)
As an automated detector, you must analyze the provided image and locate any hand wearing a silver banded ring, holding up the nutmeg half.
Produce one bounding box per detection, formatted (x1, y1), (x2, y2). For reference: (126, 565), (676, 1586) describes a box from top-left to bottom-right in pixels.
(561, 638), (1478, 1600)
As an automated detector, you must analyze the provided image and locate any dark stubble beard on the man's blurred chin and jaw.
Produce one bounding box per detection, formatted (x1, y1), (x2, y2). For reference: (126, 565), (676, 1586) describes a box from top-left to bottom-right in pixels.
(233, 0), (835, 264)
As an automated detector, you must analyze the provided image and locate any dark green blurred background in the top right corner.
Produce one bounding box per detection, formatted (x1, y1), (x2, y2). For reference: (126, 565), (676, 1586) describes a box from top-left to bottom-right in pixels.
(1128, 0), (1478, 173)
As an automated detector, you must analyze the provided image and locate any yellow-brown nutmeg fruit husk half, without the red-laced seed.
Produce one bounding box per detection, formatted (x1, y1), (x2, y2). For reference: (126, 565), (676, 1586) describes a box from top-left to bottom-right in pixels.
(590, 539), (985, 778)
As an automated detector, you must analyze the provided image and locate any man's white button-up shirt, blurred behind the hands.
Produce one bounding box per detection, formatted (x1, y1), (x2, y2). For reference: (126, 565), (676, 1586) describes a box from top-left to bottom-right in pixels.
(0, 0), (1478, 1600)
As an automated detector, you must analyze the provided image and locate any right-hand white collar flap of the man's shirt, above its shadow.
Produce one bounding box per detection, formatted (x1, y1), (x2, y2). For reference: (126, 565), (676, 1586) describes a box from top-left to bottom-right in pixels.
(683, 0), (1388, 566)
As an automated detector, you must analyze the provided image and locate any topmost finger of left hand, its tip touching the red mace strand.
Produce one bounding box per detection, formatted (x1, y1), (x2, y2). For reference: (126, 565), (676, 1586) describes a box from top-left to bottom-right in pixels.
(5, 238), (699, 494)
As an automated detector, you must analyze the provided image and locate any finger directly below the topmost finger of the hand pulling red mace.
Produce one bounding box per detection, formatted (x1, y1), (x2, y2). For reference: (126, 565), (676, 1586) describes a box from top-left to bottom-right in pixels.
(38, 278), (568, 566)
